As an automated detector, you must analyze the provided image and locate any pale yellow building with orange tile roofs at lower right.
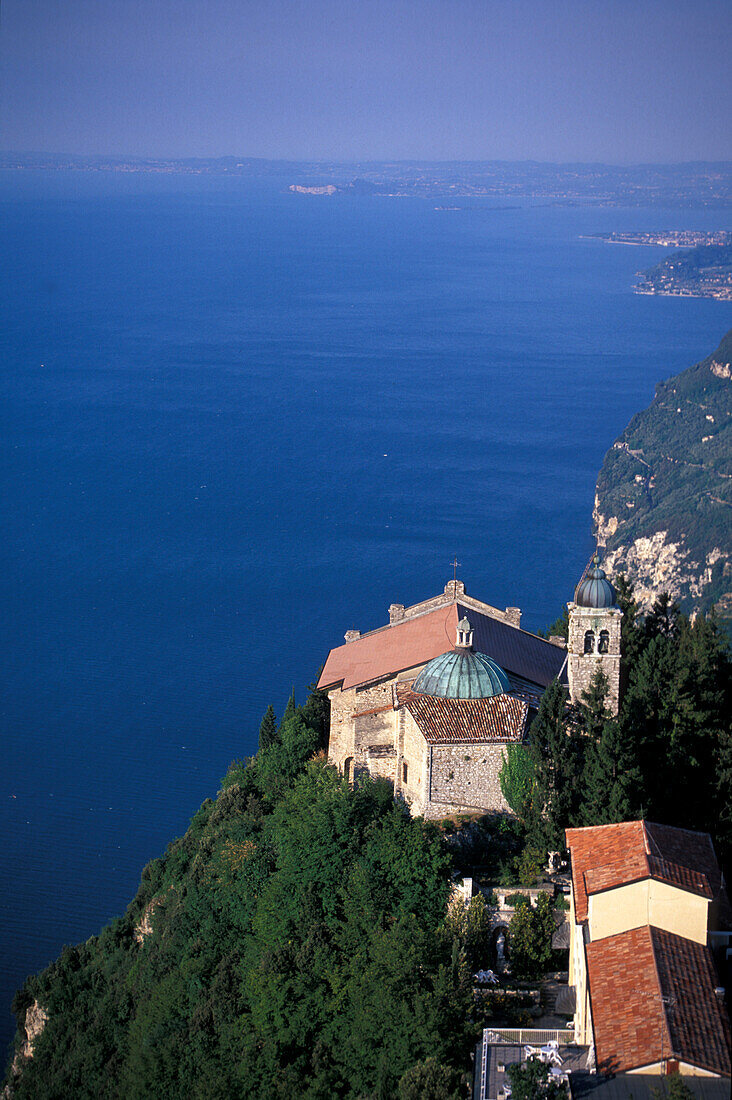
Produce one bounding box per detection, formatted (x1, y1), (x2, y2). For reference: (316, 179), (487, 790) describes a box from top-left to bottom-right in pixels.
(567, 822), (730, 1077)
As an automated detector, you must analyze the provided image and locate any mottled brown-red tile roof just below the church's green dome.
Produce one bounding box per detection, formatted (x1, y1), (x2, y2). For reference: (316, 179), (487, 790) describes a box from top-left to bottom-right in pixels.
(394, 683), (528, 745)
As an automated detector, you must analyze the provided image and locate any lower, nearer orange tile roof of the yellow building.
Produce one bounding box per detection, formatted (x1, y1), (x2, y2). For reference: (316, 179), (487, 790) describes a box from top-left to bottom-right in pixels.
(586, 925), (730, 1076)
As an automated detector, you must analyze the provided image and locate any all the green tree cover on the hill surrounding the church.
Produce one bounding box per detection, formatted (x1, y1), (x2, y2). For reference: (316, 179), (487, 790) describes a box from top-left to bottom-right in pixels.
(3, 579), (732, 1100)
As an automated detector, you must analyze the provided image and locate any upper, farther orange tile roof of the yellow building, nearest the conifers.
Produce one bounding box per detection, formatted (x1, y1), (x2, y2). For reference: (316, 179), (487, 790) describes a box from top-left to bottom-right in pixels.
(567, 822), (721, 921)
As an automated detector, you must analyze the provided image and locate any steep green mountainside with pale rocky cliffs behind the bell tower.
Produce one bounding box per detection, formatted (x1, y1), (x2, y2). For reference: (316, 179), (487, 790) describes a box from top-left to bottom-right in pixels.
(594, 331), (732, 623)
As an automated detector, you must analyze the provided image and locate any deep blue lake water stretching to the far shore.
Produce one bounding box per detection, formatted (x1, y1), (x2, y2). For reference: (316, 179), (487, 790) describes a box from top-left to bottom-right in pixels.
(0, 172), (732, 1041)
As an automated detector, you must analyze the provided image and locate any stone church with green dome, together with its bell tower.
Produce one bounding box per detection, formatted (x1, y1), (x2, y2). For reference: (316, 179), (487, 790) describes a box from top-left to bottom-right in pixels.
(318, 558), (622, 818)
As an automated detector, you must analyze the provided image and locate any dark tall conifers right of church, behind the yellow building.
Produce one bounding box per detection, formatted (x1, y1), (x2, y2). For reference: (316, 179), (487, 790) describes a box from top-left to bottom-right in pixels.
(501, 578), (732, 870)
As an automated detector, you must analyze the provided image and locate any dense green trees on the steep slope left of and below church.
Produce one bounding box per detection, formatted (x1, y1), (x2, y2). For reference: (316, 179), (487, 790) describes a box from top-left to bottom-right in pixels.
(4, 694), (474, 1100)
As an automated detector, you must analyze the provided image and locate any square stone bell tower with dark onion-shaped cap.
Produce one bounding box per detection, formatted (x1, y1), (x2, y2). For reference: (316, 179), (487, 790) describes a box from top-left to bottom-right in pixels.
(567, 553), (623, 714)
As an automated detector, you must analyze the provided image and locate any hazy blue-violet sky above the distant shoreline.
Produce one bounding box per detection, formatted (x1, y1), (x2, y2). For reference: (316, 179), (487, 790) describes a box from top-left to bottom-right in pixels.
(0, 0), (732, 163)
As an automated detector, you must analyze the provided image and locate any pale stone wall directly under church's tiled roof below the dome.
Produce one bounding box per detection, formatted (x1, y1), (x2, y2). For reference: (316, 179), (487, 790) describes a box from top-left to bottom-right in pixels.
(425, 744), (511, 817)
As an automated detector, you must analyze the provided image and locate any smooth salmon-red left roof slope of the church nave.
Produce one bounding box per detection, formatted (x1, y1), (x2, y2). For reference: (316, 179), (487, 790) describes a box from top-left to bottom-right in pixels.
(318, 604), (458, 691)
